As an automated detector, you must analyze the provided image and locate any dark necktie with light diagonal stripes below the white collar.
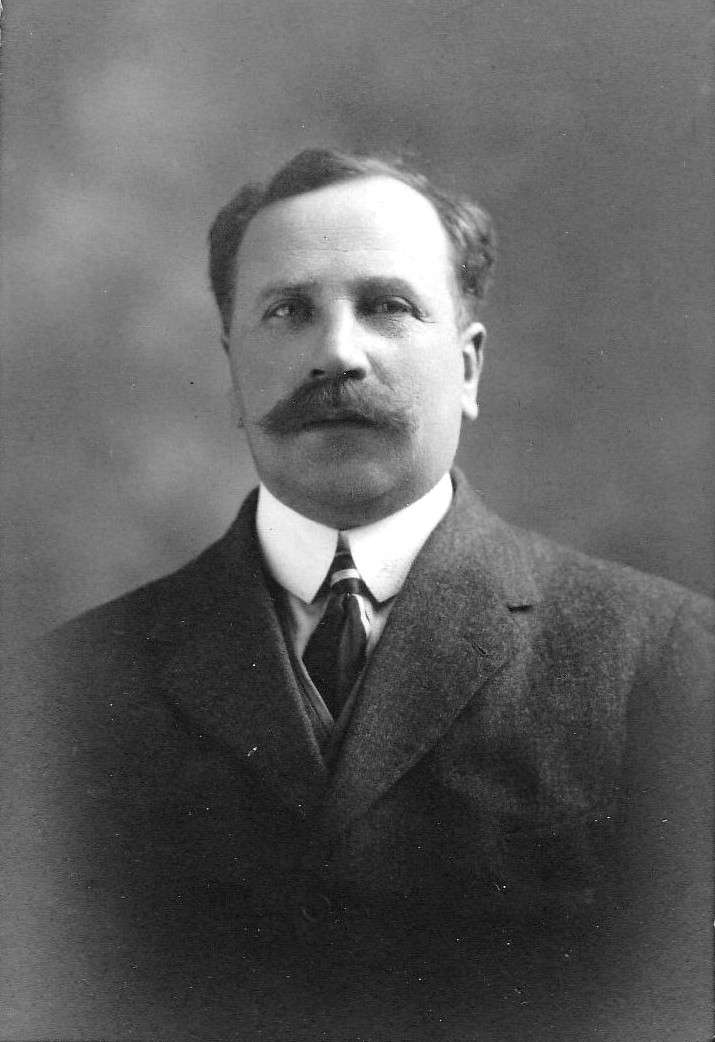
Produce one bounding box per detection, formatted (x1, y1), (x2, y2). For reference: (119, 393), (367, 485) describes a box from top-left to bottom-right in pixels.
(303, 547), (370, 717)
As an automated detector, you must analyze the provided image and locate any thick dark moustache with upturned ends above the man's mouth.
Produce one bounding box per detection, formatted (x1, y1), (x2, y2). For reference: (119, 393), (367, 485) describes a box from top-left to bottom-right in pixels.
(258, 376), (415, 437)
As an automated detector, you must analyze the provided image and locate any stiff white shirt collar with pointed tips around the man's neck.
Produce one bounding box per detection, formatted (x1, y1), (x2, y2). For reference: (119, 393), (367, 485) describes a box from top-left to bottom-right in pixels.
(255, 474), (452, 604)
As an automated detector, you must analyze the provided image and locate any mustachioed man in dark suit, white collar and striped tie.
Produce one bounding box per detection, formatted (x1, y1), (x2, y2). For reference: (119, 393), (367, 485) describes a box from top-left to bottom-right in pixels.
(4, 151), (713, 1042)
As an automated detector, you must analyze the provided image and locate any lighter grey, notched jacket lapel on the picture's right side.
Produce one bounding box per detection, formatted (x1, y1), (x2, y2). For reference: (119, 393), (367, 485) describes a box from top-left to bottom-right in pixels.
(323, 472), (535, 835)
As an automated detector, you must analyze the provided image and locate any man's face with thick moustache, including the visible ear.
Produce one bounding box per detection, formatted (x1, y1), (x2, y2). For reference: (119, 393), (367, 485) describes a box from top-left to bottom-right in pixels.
(228, 177), (484, 528)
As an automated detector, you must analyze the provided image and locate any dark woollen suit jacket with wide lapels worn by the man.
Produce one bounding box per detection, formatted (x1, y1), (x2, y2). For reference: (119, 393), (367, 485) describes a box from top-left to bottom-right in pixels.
(8, 474), (713, 1042)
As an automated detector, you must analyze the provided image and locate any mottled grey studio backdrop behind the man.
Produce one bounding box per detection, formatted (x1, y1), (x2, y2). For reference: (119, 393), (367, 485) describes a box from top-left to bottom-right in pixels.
(2, 0), (715, 643)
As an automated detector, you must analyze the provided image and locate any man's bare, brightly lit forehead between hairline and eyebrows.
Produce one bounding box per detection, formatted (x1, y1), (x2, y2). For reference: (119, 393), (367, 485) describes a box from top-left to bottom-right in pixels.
(232, 177), (453, 302)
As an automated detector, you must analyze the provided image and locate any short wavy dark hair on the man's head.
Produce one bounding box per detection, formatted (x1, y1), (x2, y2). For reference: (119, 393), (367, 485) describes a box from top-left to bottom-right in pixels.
(208, 149), (494, 334)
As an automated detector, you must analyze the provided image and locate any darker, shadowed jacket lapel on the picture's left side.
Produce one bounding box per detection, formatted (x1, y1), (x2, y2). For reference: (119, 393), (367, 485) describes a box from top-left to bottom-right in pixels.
(150, 494), (327, 816)
